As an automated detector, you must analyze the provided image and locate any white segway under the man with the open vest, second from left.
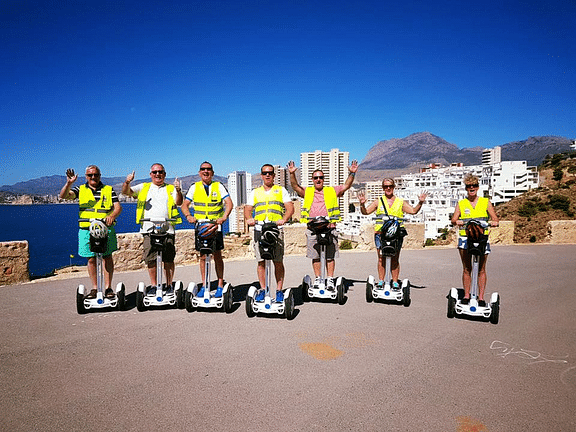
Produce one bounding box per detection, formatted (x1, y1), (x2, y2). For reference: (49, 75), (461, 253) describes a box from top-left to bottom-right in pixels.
(136, 219), (184, 312)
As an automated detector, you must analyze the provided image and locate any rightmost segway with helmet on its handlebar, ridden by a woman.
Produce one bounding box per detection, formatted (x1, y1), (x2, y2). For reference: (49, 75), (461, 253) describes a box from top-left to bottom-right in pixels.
(447, 219), (500, 324)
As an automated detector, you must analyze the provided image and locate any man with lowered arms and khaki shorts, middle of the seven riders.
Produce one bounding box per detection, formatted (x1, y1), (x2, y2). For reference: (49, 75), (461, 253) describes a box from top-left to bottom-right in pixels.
(244, 164), (294, 302)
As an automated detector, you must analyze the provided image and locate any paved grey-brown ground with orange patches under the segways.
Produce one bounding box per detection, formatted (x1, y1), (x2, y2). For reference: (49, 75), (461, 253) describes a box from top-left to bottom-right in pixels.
(0, 245), (576, 432)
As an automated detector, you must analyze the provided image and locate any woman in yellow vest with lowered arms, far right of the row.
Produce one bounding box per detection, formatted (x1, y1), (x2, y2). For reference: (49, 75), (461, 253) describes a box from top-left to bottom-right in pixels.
(452, 174), (498, 307)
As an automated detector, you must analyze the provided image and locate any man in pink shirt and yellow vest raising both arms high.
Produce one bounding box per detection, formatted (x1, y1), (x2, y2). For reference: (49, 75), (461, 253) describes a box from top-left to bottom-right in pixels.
(288, 160), (358, 289)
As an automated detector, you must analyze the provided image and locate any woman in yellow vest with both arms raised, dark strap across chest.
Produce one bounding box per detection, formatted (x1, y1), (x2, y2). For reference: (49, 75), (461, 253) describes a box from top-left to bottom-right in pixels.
(358, 178), (428, 289)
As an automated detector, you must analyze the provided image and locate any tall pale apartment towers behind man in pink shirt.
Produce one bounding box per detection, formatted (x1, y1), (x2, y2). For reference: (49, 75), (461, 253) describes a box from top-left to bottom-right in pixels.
(300, 149), (350, 219)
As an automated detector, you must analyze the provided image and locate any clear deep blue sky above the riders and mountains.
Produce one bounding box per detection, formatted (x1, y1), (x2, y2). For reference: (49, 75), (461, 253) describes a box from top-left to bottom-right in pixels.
(0, 0), (576, 185)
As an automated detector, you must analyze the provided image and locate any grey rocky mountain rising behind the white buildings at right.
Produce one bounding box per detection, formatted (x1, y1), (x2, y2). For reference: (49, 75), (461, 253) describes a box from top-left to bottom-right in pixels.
(360, 132), (571, 170)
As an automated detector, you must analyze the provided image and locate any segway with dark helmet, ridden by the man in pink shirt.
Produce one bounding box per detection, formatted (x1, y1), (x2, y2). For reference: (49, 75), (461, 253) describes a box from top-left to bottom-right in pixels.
(302, 216), (346, 305)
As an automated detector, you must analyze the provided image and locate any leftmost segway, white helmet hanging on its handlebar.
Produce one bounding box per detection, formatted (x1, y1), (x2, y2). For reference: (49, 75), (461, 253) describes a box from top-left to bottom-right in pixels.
(76, 219), (126, 314)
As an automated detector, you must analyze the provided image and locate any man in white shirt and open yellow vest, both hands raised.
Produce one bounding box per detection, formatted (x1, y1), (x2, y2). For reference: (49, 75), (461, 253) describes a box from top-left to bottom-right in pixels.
(122, 163), (183, 289)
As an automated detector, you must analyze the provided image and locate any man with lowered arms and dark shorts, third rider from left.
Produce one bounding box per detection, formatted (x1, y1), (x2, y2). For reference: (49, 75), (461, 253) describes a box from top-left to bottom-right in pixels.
(182, 162), (234, 297)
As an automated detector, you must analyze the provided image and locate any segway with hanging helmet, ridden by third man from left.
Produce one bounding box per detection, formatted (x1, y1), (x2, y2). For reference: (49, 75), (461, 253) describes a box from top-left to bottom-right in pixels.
(184, 220), (234, 313)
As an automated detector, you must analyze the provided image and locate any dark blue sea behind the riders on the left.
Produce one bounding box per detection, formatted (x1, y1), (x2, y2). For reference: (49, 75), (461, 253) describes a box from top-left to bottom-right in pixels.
(0, 202), (228, 278)
